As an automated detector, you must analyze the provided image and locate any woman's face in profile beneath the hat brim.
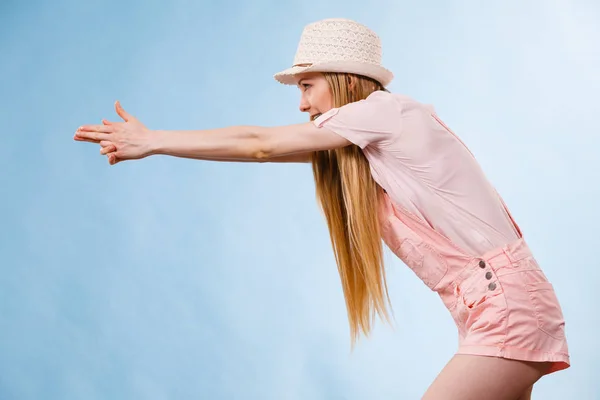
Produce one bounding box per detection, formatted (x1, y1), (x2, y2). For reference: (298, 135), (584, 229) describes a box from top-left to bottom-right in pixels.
(296, 72), (333, 121)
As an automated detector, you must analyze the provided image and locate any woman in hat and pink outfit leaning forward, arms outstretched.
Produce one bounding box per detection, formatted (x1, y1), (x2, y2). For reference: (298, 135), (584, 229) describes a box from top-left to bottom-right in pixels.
(75, 19), (569, 400)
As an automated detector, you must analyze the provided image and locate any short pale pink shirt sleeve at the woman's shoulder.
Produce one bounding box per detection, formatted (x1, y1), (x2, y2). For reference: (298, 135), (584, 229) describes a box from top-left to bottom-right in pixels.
(313, 91), (401, 149)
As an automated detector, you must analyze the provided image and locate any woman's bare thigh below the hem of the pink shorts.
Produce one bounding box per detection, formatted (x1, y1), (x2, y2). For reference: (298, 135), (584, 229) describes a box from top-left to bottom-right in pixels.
(422, 355), (549, 400)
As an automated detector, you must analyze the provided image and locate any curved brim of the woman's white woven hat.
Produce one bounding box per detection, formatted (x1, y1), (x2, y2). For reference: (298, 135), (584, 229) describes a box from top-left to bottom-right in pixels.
(273, 61), (394, 87)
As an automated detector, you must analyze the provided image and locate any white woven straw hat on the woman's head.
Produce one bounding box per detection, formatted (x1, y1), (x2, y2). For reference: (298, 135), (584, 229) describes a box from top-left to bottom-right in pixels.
(274, 18), (394, 87)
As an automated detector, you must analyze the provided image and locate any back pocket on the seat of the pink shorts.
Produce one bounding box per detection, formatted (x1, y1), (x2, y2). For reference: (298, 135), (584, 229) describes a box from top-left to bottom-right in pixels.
(527, 281), (565, 340)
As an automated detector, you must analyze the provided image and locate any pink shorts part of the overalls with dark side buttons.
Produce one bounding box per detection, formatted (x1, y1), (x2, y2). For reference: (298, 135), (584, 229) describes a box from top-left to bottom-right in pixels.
(439, 239), (569, 373)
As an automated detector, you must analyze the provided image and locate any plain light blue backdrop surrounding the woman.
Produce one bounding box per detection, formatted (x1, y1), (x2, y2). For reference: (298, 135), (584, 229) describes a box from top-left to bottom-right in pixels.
(0, 0), (600, 400)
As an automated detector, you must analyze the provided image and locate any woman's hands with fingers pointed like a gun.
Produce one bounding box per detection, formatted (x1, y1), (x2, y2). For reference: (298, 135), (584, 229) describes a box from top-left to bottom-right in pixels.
(73, 101), (153, 165)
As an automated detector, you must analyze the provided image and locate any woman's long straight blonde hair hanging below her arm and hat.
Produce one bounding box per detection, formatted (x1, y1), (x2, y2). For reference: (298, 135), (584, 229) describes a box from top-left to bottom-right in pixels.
(311, 72), (391, 346)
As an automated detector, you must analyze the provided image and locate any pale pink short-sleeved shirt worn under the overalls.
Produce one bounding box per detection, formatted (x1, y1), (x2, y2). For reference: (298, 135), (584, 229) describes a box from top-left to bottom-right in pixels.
(314, 91), (519, 255)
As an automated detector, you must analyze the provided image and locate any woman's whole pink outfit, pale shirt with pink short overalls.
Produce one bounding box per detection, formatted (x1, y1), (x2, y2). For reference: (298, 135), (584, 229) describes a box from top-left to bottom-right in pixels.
(314, 92), (570, 373)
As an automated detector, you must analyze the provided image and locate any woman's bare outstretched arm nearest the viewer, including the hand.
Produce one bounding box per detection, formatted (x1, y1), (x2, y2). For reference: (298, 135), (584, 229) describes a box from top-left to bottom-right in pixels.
(75, 102), (351, 164)
